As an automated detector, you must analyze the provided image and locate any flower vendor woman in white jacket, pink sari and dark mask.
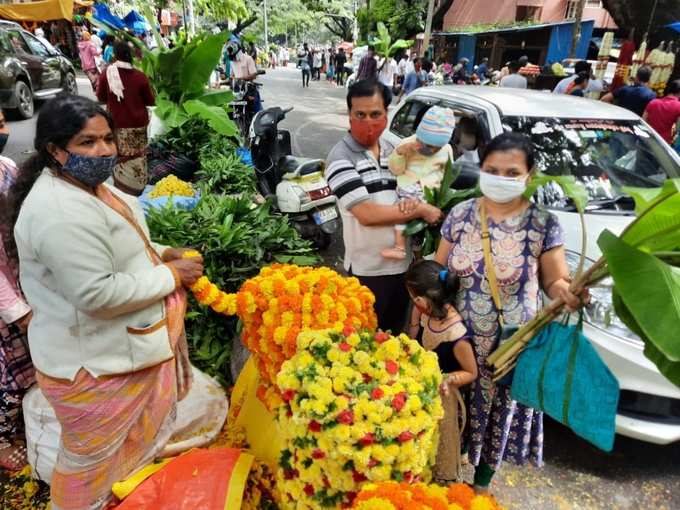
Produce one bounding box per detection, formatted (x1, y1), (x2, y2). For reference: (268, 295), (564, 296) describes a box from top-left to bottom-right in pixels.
(5, 96), (203, 510)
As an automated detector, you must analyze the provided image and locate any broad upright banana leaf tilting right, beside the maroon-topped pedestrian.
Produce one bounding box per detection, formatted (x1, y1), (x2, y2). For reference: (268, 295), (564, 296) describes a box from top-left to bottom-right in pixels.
(179, 32), (229, 97)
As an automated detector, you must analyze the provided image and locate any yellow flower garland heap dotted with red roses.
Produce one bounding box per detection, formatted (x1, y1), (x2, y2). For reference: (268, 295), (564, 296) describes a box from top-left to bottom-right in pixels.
(277, 330), (443, 510)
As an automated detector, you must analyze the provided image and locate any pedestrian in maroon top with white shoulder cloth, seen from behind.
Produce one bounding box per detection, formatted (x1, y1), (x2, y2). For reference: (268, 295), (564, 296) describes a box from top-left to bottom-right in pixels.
(97, 41), (155, 195)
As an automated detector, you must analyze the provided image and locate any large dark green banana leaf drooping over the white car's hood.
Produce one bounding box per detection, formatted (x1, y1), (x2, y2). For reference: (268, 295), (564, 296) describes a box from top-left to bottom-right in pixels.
(598, 230), (680, 362)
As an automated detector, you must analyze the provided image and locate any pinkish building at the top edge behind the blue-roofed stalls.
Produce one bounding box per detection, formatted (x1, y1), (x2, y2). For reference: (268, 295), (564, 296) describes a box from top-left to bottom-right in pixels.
(444, 0), (616, 30)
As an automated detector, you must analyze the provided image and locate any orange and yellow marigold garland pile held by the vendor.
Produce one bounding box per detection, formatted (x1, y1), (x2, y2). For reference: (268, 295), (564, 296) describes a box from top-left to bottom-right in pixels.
(184, 251), (377, 402)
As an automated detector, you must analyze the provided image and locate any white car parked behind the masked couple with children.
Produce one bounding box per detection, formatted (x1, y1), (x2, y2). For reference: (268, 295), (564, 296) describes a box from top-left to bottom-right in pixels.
(383, 85), (680, 444)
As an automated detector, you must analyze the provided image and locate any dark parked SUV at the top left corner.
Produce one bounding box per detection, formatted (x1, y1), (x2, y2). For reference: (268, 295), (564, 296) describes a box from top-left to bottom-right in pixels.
(0, 21), (78, 119)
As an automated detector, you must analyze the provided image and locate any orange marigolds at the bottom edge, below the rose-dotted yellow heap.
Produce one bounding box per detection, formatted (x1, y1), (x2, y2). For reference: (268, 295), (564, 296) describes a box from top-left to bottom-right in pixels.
(352, 481), (502, 510)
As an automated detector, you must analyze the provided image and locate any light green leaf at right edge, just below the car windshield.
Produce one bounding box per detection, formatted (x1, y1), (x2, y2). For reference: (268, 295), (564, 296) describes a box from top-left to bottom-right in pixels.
(621, 179), (680, 252)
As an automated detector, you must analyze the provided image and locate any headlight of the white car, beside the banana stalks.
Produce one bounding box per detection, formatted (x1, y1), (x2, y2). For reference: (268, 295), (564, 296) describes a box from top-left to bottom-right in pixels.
(567, 250), (641, 342)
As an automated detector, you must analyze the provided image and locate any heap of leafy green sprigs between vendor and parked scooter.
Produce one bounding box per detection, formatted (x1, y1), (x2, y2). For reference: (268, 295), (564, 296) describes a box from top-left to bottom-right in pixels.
(147, 181), (319, 385)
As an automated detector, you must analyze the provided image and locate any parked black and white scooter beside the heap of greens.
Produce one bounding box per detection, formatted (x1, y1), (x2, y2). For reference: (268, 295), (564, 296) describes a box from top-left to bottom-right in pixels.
(249, 106), (340, 249)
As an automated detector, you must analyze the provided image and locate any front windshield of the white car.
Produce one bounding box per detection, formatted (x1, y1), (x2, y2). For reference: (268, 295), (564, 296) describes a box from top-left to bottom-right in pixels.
(503, 117), (680, 210)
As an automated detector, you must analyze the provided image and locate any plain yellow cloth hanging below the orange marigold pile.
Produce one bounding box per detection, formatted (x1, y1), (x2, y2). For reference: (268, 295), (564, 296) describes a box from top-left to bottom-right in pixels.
(227, 356), (283, 467)
